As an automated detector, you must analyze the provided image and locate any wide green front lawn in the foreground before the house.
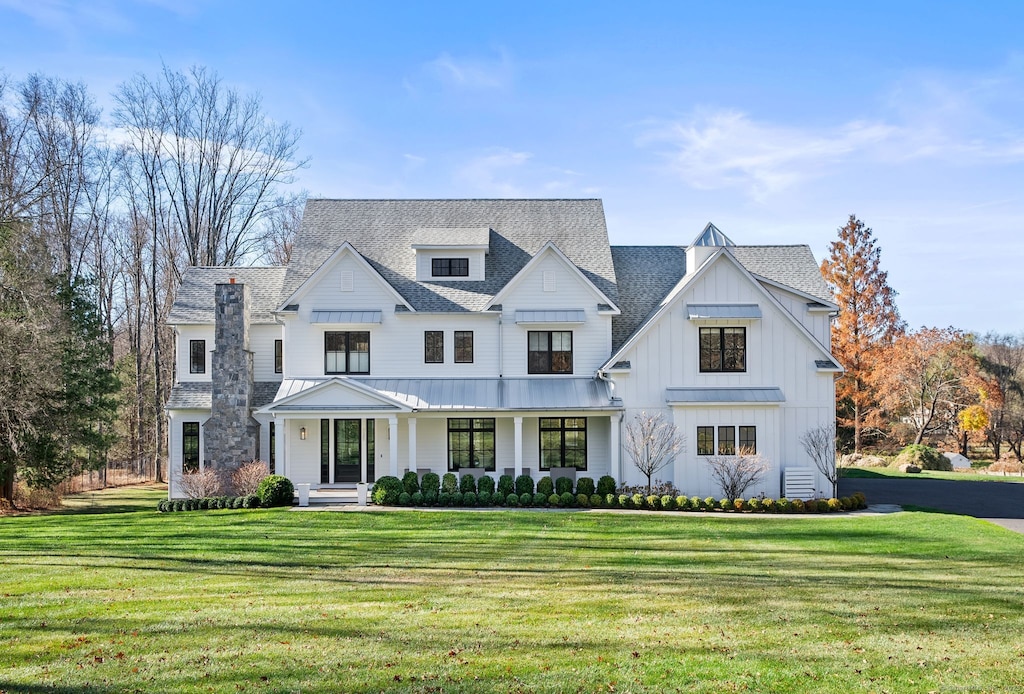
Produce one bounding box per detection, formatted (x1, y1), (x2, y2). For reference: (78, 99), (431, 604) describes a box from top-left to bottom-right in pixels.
(0, 491), (1024, 692)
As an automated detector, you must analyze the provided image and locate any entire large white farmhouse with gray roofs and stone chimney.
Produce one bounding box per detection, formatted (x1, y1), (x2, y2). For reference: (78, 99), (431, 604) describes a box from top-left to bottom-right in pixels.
(167, 200), (842, 497)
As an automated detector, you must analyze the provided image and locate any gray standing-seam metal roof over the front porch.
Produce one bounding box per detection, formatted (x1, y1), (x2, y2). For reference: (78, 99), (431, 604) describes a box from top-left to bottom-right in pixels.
(275, 377), (622, 411)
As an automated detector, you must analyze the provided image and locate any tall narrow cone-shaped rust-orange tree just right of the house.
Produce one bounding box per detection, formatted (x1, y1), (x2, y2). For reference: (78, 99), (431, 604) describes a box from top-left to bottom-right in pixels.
(821, 215), (904, 452)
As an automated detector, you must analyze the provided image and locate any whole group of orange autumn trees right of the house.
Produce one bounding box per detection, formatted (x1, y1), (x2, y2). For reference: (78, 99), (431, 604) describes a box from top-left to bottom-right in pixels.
(821, 215), (1024, 463)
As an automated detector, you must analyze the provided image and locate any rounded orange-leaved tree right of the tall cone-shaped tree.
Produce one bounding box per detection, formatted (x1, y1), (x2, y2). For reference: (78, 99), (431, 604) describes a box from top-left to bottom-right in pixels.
(871, 328), (991, 443)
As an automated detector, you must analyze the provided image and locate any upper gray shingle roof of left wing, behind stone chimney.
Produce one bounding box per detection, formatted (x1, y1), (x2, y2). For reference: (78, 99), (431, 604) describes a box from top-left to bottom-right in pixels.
(167, 267), (285, 326)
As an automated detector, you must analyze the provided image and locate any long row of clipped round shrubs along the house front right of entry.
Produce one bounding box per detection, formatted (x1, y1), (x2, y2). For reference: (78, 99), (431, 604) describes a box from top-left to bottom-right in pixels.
(372, 473), (867, 513)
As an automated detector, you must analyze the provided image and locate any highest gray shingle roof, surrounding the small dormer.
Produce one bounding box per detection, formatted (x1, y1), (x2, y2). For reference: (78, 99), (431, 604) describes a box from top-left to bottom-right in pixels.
(281, 200), (617, 311)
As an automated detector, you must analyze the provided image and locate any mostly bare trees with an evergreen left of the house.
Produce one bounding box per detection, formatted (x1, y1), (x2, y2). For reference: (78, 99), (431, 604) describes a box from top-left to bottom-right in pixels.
(0, 67), (306, 501)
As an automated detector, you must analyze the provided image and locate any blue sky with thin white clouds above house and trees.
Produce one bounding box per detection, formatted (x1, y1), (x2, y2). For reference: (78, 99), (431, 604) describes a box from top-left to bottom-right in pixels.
(0, 0), (1024, 333)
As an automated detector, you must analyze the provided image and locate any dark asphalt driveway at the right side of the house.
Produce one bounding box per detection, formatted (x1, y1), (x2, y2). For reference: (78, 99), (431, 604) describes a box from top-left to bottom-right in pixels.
(839, 477), (1024, 531)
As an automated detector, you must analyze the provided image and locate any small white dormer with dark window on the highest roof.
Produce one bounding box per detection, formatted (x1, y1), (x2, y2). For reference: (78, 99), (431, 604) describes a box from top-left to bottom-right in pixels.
(412, 226), (490, 283)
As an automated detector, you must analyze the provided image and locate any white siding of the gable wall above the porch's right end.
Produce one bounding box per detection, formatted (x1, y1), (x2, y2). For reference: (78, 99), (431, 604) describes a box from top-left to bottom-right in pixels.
(501, 252), (611, 377)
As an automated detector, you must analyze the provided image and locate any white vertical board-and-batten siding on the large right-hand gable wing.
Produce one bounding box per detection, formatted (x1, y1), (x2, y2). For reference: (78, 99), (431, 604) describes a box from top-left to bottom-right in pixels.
(612, 258), (835, 496)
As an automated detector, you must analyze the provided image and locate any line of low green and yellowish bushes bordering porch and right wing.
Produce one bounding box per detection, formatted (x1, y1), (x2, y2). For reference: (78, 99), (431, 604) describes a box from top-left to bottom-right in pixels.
(372, 473), (867, 513)
